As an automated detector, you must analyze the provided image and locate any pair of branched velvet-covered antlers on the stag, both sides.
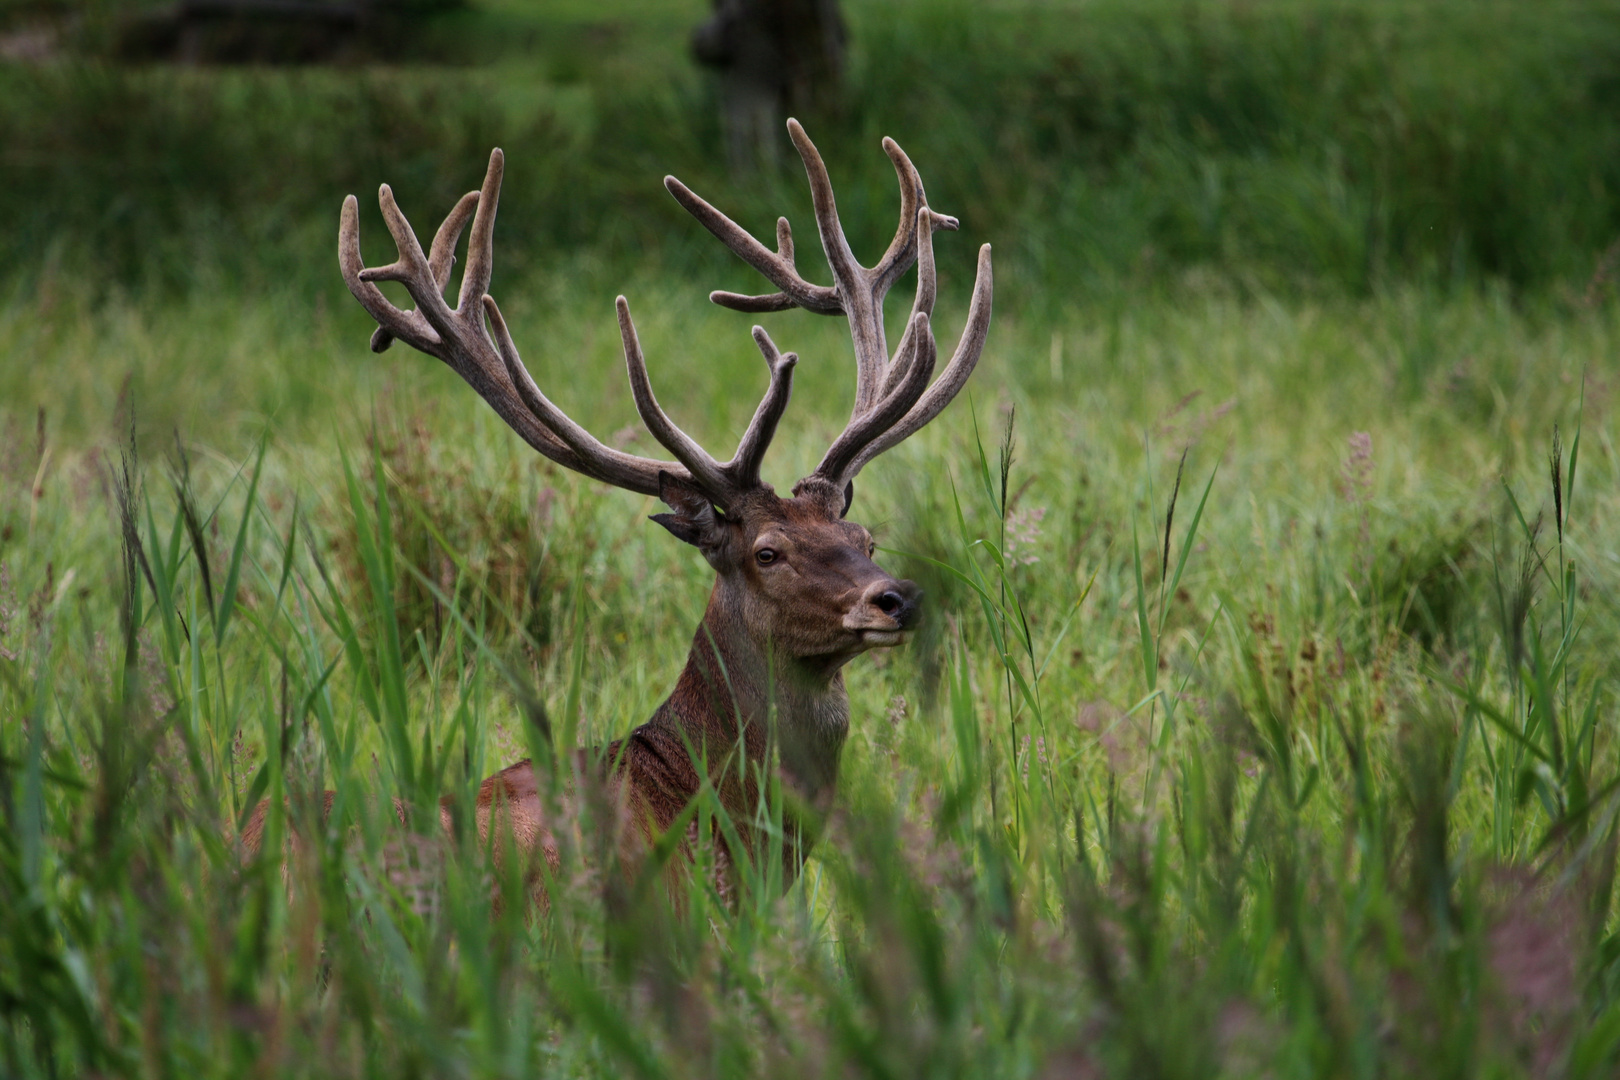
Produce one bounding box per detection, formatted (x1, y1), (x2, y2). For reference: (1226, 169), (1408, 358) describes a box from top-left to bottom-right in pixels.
(339, 128), (991, 507)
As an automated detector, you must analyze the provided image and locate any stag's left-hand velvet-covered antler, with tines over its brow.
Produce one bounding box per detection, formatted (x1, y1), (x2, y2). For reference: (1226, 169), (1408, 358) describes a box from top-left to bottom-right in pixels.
(337, 149), (799, 507)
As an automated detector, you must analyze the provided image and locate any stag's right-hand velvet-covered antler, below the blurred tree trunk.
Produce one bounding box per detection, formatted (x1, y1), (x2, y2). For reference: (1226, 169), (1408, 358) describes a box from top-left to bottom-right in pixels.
(664, 120), (991, 487)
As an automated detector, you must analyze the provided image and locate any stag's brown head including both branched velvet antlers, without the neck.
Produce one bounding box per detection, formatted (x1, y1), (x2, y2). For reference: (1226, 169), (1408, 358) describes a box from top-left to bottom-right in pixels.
(339, 120), (991, 709)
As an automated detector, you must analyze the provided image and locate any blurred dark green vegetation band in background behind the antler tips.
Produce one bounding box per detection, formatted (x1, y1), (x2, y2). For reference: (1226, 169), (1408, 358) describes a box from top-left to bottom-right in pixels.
(0, 0), (1620, 304)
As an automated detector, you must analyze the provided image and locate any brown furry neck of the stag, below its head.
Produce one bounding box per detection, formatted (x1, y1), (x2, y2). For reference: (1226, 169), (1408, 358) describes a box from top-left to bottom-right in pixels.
(651, 580), (849, 811)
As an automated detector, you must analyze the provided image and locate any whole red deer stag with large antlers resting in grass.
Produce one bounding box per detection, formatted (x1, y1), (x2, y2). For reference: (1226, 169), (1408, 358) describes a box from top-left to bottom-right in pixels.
(243, 120), (991, 906)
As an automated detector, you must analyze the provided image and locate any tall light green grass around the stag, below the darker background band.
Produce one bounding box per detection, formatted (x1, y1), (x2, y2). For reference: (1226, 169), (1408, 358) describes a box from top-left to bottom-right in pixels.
(0, 276), (1620, 1077)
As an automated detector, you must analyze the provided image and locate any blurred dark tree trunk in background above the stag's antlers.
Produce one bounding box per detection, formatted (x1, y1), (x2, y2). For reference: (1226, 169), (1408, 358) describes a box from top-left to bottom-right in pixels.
(692, 0), (844, 172)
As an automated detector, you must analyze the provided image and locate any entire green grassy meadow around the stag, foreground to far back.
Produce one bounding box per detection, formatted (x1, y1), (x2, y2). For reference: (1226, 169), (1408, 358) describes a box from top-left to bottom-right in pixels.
(0, 0), (1620, 1078)
